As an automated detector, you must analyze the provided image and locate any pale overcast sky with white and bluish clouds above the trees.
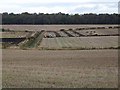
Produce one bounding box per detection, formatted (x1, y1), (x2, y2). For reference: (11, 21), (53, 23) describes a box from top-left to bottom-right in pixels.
(0, 0), (119, 14)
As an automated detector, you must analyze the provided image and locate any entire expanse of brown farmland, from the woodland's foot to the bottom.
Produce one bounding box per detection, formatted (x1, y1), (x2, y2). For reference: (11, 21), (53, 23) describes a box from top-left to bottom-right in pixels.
(0, 25), (120, 88)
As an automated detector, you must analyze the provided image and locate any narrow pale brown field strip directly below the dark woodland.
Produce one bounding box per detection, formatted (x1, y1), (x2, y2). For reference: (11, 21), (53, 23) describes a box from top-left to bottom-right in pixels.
(2, 25), (118, 31)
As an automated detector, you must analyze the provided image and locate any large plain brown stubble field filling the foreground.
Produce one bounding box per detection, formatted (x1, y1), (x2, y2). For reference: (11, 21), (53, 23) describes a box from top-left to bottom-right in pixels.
(2, 49), (118, 88)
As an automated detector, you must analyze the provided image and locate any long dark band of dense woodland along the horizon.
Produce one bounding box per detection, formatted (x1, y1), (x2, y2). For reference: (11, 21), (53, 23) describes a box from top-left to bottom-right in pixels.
(2, 12), (120, 25)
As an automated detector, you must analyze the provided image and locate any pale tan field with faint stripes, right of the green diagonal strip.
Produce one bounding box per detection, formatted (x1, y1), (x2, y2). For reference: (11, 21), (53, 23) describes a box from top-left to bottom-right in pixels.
(39, 36), (118, 49)
